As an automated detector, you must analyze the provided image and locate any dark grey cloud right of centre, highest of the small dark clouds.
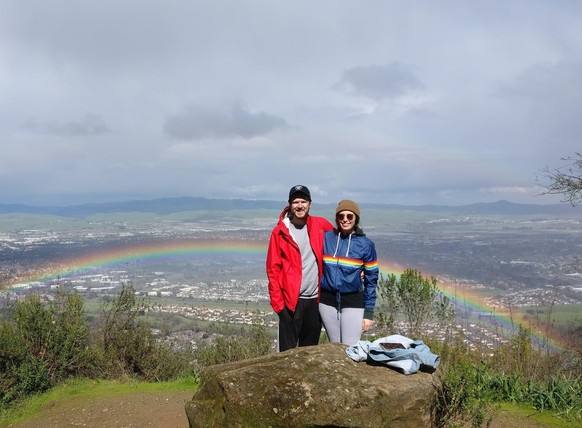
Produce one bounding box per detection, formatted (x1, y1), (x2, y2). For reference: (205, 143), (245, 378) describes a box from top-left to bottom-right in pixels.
(334, 62), (425, 101)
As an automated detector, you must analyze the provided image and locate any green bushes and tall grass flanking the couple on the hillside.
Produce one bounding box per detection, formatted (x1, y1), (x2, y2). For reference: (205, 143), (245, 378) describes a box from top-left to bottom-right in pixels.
(0, 270), (582, 427)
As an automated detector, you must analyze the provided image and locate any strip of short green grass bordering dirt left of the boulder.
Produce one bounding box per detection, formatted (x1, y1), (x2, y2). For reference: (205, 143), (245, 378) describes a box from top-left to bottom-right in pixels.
(0, 377), (198, 427)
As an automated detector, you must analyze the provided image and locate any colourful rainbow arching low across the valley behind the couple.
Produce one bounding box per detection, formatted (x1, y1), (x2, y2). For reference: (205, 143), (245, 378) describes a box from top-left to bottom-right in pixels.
(5, 244), (561, 349)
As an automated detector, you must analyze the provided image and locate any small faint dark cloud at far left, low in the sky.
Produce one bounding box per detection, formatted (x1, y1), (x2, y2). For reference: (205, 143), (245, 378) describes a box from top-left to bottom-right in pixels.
(23, 114), (110, 137)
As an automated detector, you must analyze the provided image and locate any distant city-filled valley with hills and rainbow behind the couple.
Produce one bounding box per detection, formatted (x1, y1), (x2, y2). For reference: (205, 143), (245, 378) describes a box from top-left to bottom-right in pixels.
(0, 198), (582, 347)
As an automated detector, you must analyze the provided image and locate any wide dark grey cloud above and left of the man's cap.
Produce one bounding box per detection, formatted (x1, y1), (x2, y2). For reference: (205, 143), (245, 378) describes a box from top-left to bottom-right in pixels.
(164, 104), (287, 140)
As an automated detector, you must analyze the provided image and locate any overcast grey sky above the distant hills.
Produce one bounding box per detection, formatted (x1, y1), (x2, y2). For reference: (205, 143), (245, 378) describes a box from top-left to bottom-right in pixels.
(0, 0), (582, 205)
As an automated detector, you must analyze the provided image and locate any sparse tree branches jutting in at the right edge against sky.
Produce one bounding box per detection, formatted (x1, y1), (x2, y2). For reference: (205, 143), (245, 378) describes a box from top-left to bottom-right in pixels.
(542, 152), (582, 206)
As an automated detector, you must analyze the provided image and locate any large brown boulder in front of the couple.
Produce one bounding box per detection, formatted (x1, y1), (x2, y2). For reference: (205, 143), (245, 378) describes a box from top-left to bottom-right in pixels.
(186, 343), (435, 428)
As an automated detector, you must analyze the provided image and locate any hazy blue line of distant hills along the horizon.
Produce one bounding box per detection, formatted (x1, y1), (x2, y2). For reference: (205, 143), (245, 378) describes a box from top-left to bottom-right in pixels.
(0, 197), (582, 218)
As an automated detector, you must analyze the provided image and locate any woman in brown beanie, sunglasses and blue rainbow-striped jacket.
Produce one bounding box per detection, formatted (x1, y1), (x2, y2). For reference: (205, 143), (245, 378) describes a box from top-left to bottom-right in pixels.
(319, 199), (378, 346)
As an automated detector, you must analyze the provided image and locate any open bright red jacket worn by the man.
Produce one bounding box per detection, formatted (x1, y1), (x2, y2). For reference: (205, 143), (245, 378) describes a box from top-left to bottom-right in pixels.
(267, 207), (333, 313)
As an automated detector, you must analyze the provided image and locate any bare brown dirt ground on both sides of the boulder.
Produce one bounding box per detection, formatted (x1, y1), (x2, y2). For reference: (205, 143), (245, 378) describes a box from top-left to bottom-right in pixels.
(4, 392), (556, 428)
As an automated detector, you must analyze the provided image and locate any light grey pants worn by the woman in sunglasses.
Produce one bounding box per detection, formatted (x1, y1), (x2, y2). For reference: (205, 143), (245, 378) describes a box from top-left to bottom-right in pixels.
(319, 303), (364, 346)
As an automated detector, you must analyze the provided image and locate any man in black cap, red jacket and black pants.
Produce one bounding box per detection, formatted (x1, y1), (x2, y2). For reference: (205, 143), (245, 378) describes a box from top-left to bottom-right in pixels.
(267, 185), (333, 352)
